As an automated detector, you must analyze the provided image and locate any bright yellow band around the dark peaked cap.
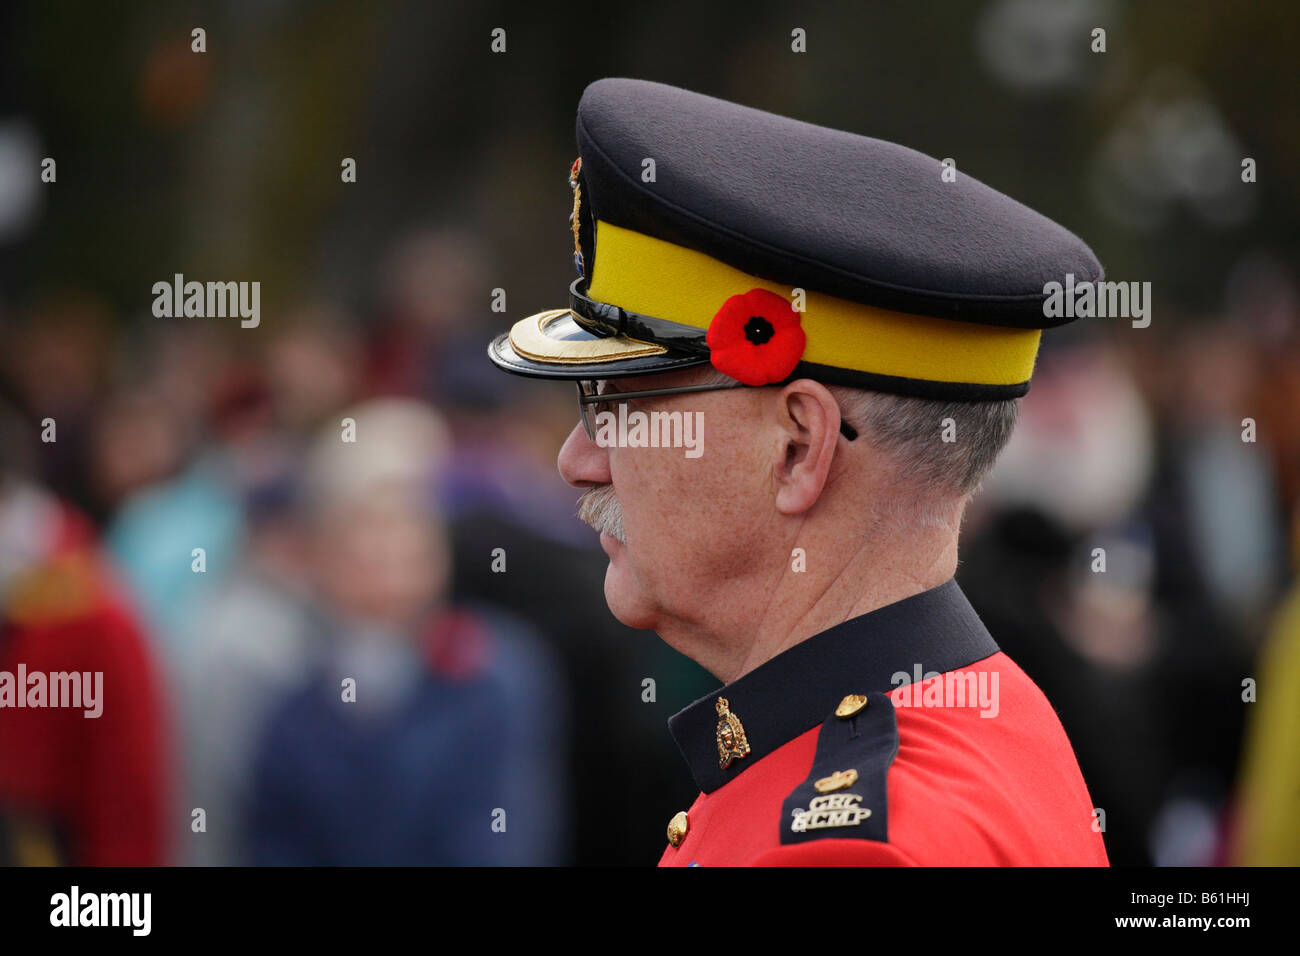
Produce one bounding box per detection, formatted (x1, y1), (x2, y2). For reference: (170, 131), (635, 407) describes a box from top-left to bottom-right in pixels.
(588, 221), (1043, 385)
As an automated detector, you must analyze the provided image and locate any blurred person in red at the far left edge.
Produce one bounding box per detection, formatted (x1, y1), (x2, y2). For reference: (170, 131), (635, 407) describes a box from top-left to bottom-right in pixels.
(0, 403), (169, 866)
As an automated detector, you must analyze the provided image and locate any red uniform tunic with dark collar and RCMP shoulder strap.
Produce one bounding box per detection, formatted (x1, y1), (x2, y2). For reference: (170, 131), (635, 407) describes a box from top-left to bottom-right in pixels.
(659, 580), (1106, 866)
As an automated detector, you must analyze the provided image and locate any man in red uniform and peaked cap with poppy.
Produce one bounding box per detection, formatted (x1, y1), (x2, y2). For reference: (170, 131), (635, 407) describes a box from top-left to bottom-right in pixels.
(489, 79), (1106, 866)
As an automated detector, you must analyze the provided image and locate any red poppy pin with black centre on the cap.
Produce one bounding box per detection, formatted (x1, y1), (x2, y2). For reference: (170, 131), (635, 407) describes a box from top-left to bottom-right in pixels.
(705, 289), (806, 385)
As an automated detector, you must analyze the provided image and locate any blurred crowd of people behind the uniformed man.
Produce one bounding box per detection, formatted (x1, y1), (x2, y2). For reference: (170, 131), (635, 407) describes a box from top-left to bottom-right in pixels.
(0, 230), (1300, 865)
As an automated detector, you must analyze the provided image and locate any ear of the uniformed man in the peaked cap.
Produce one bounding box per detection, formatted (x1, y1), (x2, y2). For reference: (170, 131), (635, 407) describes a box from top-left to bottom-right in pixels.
(774, 378), (840, 515)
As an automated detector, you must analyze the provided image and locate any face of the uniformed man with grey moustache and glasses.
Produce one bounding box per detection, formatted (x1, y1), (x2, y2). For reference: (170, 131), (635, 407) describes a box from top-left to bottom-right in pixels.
(559, 371), (776, 630)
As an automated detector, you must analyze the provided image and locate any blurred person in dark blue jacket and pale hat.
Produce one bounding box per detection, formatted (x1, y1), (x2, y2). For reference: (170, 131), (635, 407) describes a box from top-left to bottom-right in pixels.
(246, 399), (567, 865)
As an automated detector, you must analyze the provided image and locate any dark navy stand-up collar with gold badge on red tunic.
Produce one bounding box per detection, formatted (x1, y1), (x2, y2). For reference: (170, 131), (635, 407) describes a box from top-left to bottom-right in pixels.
(668, 579), (998, 793)
